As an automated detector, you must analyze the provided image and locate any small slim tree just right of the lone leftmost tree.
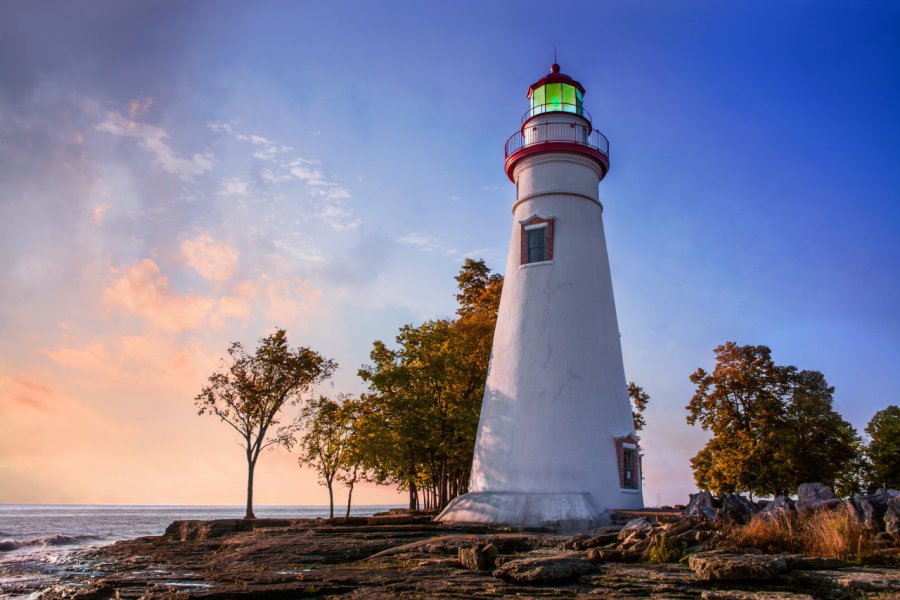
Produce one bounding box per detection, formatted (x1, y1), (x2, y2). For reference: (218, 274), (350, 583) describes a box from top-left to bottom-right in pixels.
(298, 396), (353, 518)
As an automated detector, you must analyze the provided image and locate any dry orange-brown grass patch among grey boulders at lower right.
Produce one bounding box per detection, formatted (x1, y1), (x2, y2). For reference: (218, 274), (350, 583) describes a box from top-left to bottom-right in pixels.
(726, 508), (878, 564)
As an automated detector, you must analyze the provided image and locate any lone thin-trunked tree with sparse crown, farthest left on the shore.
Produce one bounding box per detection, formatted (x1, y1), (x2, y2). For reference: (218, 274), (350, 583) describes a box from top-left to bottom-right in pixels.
(194, 329), (337, 519)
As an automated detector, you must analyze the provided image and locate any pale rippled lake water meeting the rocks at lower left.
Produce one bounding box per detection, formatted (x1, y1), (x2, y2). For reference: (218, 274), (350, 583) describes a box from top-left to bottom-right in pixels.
(0, 504), (394, 598)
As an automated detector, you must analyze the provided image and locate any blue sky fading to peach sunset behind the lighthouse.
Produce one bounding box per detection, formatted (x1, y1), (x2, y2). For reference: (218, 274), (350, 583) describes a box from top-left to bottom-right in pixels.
(0, 0), (900, 505)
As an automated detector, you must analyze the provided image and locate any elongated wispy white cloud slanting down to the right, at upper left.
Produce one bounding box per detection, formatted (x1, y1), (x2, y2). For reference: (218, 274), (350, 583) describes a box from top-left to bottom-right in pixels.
(97, 111), (216, 181)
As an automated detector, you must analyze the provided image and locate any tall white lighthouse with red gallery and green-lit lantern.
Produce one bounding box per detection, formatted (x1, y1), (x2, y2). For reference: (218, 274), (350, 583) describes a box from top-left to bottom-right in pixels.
(438, 64), (643, 529)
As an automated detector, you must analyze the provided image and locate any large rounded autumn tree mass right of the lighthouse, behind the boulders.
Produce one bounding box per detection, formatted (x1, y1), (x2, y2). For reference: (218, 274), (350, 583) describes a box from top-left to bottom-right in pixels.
(686, 342), (859, 495)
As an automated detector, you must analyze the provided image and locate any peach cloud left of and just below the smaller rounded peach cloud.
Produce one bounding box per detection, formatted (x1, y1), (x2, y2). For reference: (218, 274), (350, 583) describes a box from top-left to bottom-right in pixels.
(103, 258), (216, 331)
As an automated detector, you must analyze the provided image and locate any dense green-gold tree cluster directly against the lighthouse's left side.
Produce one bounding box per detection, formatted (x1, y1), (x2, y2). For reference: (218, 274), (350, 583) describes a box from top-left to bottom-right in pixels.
(359, 260), (503, 507)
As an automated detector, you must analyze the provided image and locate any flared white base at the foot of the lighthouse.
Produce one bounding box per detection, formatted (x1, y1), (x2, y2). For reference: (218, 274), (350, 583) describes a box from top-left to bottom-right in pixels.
(437, 492), (610, 531)
